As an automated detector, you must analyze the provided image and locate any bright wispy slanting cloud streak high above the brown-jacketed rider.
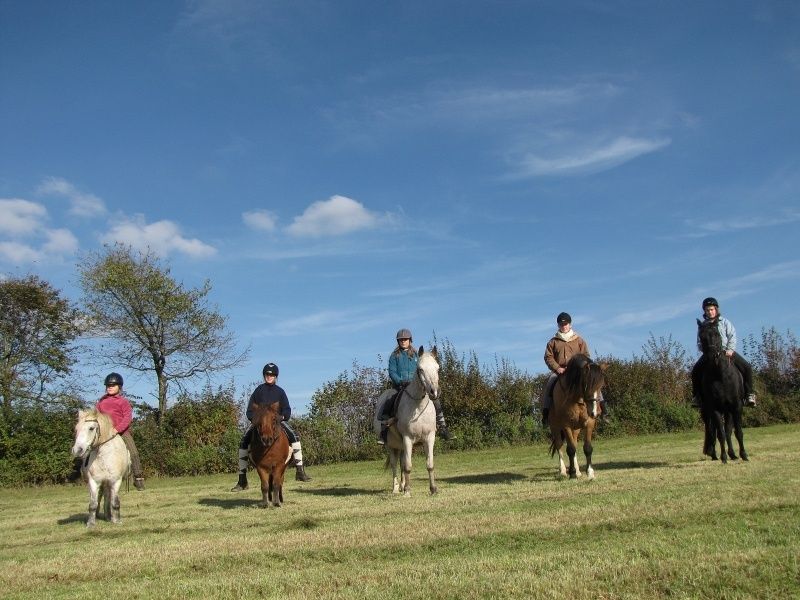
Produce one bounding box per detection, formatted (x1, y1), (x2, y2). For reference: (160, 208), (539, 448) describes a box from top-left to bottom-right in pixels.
(516, 136), (671, 177)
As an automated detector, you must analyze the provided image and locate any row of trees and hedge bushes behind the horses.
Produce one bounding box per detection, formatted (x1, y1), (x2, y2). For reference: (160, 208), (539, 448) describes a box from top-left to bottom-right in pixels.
(0, 245), (800, 486)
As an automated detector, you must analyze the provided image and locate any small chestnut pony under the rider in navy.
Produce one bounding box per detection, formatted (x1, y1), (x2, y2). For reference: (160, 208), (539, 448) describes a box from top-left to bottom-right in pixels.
(250, 402), (291, 508)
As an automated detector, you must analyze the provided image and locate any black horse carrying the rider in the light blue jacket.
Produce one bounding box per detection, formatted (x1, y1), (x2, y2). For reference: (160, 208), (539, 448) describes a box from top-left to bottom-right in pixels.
(697, 319), (748, 463)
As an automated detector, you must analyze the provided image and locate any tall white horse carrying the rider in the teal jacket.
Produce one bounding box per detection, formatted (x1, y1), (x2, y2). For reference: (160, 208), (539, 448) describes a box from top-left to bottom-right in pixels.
(372, 346), (439, 496)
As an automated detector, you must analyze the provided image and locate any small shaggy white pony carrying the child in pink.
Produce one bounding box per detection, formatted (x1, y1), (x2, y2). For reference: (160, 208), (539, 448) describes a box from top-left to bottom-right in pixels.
(72, 408), (131, 527)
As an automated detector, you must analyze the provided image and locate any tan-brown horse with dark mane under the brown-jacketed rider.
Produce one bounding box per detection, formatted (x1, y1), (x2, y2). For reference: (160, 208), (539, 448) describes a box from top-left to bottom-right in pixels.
(548, 354), (607, 479)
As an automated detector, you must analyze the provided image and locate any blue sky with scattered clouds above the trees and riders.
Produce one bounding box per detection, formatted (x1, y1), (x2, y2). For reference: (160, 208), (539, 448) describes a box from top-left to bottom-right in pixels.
(0, 0), (800, 412)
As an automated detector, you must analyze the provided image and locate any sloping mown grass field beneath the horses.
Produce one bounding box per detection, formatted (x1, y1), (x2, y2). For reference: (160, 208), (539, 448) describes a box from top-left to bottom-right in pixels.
(0, 425), (800, 600)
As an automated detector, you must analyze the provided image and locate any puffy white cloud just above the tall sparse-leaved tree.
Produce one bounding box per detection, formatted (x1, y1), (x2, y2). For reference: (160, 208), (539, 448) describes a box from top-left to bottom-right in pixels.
(102, 215), (217, 258)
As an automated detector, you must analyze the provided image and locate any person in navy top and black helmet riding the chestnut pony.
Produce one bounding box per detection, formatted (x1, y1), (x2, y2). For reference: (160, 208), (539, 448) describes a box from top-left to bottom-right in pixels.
(231, 363), (311, 492)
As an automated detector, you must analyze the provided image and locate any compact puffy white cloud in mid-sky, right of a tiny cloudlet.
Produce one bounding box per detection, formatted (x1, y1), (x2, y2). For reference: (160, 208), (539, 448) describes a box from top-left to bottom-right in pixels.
(287, 196), (380, 237)
